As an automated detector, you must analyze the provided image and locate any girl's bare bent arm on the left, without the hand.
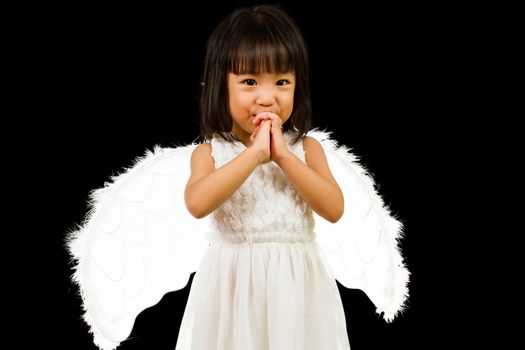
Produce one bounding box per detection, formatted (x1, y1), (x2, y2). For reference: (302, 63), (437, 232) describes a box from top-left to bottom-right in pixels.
(184, 144), (262, 219)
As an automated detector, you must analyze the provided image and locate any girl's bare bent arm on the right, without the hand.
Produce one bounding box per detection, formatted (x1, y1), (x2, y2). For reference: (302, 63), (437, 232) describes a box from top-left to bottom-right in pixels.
(276, 136), (344, 223)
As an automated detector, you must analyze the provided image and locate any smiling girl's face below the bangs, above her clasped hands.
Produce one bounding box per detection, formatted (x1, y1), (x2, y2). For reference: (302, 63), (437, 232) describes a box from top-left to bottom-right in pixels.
(228, 72), (295, 142)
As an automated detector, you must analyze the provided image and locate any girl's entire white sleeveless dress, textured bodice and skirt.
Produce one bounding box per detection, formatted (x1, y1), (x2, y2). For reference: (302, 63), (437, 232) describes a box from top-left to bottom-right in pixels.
(175, 132), (350, 350)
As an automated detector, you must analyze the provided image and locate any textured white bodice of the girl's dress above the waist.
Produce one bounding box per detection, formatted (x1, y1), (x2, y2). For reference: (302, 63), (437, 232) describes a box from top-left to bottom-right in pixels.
(210, 132), (315, 243)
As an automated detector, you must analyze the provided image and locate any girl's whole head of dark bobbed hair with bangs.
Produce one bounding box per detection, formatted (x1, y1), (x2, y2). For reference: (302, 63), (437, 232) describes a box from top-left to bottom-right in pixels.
(196, 5), (312, 143)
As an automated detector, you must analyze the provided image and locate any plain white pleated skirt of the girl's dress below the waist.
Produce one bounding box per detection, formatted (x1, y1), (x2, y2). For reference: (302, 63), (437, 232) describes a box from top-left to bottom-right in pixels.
(175, 241), (350, 350)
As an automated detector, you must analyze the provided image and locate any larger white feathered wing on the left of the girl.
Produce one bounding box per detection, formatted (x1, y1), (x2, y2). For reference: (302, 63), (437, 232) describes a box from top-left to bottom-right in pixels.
(67, 144), (210, 350)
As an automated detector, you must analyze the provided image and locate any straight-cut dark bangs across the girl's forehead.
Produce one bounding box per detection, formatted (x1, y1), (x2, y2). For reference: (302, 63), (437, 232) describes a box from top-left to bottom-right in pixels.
(227, 30), (300, 75)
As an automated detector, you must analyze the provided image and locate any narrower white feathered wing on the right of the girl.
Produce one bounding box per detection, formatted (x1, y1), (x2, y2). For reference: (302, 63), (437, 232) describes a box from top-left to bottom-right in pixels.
(308, 129), (410, 322)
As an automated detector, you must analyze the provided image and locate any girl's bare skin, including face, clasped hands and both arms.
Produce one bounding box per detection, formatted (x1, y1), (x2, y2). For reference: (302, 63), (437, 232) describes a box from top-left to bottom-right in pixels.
(184, 69), (344, 222)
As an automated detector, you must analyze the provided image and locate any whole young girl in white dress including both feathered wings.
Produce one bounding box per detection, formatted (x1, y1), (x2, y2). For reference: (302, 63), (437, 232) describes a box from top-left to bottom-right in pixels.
(69, 5), (408, 350)
